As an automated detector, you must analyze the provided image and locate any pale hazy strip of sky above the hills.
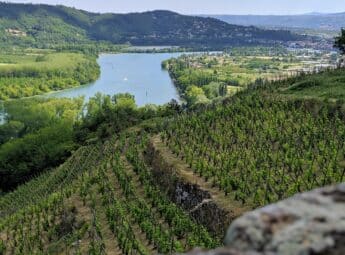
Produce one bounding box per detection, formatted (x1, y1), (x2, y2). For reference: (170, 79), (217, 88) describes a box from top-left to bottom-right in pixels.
(6, 0), (345, 14)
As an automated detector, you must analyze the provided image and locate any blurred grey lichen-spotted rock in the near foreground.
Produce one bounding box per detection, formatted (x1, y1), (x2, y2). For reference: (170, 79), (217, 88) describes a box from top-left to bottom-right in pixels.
(184, 183), (345, 255)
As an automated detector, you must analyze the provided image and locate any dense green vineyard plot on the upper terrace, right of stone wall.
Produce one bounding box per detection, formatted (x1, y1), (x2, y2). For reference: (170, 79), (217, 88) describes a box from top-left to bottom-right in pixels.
(161, 93), (345, 207)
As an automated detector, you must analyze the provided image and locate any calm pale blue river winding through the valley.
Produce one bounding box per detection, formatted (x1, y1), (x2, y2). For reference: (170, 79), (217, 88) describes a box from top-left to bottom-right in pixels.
(44, 53), (182, 106)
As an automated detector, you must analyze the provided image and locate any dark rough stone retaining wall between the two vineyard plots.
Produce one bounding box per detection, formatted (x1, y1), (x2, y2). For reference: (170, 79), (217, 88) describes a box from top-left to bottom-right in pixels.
(144, 139), (232, 238)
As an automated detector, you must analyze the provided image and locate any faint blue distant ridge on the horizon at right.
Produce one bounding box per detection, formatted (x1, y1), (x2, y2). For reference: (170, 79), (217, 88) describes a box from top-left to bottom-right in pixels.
(201, 12), (345, 31)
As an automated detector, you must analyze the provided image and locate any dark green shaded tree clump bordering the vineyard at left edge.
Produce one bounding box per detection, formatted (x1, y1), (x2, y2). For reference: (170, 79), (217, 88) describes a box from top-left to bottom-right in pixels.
(0, 123), (75, 191)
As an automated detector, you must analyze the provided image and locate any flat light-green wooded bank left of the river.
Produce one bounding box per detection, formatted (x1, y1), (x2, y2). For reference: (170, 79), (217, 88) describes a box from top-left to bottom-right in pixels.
(0, 52), (100, 100)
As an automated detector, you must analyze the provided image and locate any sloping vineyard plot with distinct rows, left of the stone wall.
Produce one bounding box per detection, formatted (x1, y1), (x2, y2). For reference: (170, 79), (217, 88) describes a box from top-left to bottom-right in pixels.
(0, 133), (220, 254)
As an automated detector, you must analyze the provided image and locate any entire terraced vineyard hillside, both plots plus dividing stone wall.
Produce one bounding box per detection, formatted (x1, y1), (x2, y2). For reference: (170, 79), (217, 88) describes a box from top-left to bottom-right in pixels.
(0, 68), (345, 254)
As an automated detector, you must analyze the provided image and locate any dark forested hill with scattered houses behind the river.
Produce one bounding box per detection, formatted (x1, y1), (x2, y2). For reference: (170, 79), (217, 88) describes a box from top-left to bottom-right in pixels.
(0, 3), (304, 47)
